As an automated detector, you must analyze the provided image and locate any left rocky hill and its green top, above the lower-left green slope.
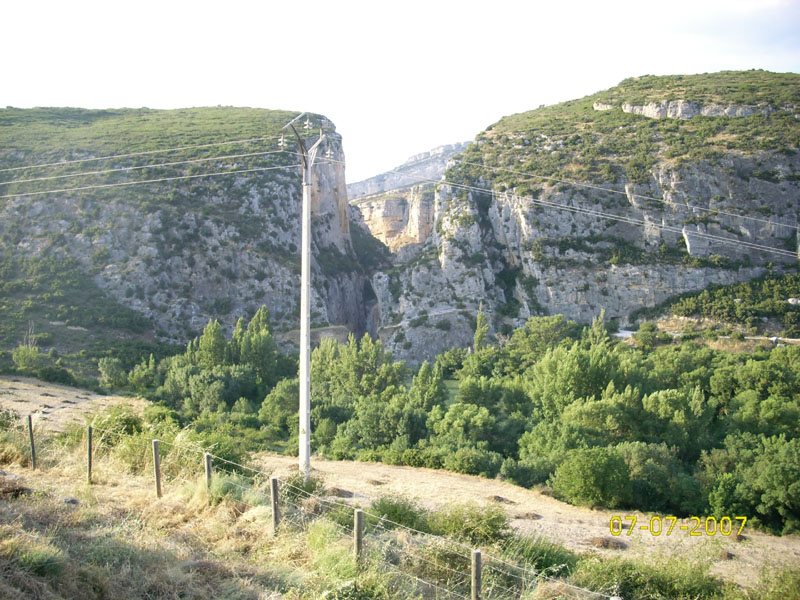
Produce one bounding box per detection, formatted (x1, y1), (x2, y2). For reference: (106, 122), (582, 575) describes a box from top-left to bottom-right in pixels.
(0, 108), (376, 347)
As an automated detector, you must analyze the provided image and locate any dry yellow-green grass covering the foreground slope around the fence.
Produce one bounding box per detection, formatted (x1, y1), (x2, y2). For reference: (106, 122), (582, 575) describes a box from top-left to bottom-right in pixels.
(0, 412), (800, 600)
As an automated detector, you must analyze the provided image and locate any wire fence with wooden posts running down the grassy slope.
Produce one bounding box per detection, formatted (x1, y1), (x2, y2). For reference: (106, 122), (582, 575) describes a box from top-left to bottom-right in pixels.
(0, 412), (617, 600)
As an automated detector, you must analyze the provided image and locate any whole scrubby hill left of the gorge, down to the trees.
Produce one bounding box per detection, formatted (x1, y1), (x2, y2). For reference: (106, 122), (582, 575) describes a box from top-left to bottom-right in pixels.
(0, 107), (370, 375)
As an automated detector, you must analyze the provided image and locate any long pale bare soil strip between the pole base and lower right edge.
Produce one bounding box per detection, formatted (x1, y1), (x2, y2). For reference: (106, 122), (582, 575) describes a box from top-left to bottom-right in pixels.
(258, 454), (800, 587)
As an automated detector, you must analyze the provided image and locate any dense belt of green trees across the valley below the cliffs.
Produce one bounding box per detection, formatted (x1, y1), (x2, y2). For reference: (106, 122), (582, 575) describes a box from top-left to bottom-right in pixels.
(100, 307), (800, 533)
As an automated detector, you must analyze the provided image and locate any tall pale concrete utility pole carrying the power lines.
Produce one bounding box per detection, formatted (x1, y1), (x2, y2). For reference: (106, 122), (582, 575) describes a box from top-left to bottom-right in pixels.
(284, 113), (325, 481)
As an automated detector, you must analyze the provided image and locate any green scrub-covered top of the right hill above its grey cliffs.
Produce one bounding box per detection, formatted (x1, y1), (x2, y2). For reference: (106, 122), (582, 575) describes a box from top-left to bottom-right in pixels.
(449, 71), (800, 185)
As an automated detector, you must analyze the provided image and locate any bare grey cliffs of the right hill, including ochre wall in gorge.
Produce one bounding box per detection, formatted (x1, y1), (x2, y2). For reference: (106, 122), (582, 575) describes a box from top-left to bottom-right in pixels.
(353, 71), (800, 362)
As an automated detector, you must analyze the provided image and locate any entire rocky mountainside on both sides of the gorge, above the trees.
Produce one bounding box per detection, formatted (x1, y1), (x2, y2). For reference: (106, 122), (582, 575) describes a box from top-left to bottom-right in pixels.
(0, 71), (800, 362)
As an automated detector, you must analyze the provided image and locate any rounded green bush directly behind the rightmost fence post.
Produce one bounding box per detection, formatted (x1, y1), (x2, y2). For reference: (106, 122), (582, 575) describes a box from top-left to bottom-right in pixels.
(428, 502), (511, 545)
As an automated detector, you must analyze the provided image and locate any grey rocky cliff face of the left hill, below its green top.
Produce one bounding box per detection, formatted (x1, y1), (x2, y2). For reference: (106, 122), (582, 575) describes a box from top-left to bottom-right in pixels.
(0, 109), (369, 342)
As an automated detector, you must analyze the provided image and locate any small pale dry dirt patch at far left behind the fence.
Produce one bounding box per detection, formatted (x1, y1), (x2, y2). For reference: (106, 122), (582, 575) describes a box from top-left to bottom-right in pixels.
(0, 376), (145, 432)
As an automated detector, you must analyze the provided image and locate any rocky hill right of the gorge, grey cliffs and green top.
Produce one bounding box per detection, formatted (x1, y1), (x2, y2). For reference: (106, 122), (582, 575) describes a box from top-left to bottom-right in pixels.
(355, 72), (800, 359)
